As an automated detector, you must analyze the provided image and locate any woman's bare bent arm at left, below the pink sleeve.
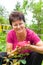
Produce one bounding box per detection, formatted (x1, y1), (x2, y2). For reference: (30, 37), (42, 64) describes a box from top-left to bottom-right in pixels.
(6, 43), (18, 57)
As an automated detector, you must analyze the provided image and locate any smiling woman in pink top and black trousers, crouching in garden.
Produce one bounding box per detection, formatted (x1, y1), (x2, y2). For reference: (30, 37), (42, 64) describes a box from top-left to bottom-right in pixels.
(6, 11), (43, 65)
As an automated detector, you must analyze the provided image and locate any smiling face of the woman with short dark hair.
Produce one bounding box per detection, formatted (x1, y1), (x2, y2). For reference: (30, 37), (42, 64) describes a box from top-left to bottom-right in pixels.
(12, 20), (25, 33)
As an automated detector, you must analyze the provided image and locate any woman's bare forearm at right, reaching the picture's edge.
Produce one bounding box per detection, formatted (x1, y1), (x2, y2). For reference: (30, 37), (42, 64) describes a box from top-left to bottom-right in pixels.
(27, 41), (43, 54)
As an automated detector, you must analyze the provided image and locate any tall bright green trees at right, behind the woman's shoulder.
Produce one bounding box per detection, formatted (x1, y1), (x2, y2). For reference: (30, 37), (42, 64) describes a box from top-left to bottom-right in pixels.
(29, 0), (43, 39)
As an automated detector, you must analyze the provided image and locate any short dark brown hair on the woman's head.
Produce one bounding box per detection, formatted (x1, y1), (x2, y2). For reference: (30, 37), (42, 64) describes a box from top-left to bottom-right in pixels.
(9, 11), (25, 25)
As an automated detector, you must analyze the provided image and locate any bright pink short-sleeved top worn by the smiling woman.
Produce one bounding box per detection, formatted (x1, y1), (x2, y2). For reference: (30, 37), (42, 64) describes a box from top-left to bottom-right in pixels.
(6, 28), (40, 53)
